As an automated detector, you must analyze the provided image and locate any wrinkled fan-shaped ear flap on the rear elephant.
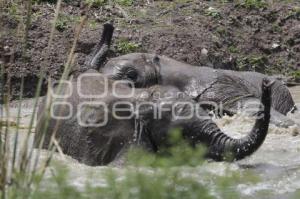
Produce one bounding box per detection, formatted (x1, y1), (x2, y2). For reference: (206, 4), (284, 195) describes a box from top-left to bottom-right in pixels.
(198, 73), (259, 108)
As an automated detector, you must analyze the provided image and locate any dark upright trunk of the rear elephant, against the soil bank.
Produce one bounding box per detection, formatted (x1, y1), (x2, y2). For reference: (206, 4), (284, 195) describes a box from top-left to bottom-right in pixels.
(85, 23), (114, 70)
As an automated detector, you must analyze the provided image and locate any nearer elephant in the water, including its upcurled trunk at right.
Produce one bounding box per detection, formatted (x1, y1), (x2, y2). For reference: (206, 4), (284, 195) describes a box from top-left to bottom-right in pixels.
(35, 70), (271, 165)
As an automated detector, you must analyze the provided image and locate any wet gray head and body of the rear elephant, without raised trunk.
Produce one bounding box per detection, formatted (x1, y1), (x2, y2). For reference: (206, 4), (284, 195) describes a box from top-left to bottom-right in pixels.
(100, 53), (295, 127)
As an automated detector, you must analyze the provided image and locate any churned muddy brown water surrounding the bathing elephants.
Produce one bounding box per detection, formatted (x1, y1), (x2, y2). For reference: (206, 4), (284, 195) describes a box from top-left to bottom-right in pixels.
(1, 87), (300, 198)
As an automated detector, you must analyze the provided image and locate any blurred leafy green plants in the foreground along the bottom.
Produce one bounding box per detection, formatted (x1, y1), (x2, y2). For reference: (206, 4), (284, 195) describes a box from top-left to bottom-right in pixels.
(1, 131), (259, 199)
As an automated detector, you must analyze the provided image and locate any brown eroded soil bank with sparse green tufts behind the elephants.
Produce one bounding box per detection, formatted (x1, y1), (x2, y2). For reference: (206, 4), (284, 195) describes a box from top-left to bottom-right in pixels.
(0, 0), (300, 98)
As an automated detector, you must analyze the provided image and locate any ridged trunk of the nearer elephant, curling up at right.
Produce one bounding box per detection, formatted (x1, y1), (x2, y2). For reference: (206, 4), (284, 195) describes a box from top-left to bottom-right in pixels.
(195, 79), (272, 161)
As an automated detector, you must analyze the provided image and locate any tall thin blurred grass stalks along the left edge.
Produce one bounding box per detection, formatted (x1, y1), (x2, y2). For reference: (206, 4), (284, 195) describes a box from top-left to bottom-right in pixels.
(0, 0), (86, 199)
